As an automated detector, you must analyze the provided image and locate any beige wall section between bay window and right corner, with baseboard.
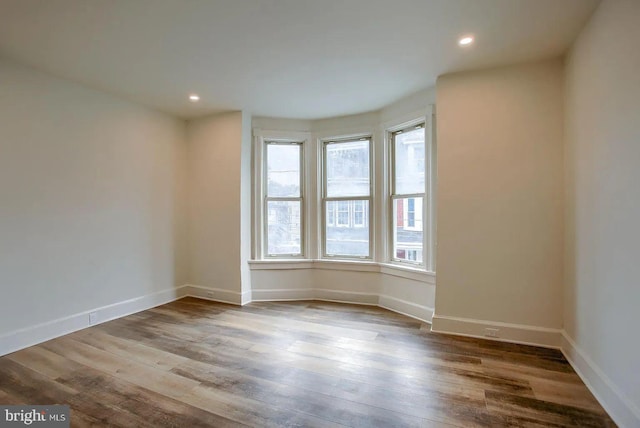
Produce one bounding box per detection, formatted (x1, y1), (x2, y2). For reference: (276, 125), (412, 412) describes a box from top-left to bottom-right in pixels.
(433, 60), (563, 345)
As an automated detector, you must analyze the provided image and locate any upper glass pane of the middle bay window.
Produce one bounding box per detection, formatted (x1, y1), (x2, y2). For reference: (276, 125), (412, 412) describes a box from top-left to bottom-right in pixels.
(326, 140), (369, 197)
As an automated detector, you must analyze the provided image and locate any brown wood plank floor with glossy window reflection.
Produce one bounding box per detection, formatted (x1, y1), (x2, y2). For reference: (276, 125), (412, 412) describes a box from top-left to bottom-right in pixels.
(0, 298), (615, 427)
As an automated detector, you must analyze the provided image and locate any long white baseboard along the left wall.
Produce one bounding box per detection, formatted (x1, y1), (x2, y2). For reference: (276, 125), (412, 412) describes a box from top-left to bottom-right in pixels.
(0, 286), (186, 356)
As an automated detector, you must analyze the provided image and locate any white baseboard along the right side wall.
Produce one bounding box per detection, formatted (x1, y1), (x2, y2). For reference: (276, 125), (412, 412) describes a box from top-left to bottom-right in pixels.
(560, 330), (640, 428)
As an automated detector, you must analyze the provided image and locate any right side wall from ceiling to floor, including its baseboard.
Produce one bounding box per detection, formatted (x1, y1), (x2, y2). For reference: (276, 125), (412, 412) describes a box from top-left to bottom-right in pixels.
(563, 0), (640, 427)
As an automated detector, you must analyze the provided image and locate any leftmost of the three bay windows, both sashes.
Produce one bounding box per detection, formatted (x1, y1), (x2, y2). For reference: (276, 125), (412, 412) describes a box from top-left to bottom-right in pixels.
(263, 141), (303, 257)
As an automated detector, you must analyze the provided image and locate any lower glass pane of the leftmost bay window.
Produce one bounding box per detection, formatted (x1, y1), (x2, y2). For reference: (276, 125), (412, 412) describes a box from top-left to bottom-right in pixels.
(267, 201), (301, 255)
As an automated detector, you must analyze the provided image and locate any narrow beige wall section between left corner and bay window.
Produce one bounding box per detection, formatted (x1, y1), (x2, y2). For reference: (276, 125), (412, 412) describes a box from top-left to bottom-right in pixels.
(187, 112), (251, 304)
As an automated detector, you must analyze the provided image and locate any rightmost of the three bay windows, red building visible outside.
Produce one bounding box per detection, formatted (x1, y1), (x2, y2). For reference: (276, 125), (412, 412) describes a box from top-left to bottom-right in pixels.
(390, 124), (426, 265)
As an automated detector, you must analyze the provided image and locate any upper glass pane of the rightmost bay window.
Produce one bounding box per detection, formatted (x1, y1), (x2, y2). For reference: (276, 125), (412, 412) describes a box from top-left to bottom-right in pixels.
(394, 128), (425, 195)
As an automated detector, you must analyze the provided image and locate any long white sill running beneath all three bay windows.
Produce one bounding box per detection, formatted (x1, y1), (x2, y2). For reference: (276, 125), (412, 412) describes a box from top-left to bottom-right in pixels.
(249, 259), (436, 285)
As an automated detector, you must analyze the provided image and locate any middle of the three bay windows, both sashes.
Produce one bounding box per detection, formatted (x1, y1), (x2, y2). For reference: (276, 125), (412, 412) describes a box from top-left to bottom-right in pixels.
(322, 137), (371, 258)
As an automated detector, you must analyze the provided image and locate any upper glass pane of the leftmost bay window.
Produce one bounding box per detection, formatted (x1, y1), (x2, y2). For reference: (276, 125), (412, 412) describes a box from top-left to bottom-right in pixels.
(267, 144), (300, 197)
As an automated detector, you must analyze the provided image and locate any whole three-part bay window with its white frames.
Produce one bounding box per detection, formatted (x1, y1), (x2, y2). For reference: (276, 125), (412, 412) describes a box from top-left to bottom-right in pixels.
(252, 108), (437, 275)
